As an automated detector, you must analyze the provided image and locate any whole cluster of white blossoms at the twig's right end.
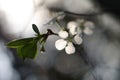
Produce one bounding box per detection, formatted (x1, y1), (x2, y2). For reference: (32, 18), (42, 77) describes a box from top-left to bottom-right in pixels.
(55, 20), (94, 54)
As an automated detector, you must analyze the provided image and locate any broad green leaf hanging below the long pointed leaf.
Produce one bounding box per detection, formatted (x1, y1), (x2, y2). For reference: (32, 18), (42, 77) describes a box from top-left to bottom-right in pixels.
(17, 43), (37, 59)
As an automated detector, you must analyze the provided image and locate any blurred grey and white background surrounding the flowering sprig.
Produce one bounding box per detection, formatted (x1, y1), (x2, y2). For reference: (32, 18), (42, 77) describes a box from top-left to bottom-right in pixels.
(0, 0), (120, 80)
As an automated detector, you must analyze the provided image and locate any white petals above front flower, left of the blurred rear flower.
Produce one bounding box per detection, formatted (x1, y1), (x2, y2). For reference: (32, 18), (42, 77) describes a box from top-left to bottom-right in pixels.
(67, 21), (81, 35)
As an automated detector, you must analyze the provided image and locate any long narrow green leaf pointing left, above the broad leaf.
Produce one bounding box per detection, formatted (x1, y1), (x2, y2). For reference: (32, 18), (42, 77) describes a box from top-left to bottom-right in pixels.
(7, 37), (35, 48)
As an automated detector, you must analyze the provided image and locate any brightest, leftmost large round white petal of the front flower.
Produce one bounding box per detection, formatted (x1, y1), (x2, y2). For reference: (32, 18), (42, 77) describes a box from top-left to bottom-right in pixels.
(55, 39), (67, 50)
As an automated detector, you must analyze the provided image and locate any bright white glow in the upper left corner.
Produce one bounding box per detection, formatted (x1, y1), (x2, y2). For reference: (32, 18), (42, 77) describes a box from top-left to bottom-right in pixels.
(0, 0), (34, 33)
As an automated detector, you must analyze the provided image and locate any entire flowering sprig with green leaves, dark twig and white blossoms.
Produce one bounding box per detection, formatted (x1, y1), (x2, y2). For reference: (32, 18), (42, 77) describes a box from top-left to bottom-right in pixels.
(7, 12), (95, 60)
